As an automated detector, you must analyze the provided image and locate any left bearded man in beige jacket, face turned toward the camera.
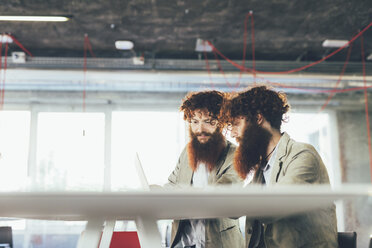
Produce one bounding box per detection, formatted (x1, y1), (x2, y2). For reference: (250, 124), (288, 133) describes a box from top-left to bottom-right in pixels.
(168, 91), (244, 248)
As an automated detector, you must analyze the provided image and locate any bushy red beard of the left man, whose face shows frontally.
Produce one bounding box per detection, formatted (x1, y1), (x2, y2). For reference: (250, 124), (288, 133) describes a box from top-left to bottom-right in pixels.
(187, 128), (226, 171)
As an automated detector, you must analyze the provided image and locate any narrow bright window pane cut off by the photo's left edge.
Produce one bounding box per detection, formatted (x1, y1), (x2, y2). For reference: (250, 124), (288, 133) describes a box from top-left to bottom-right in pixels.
(0, 111), (31, 191)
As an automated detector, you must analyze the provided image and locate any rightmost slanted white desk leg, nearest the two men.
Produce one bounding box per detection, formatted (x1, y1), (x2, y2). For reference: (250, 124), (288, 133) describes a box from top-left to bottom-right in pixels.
(136, 217), (162, 248)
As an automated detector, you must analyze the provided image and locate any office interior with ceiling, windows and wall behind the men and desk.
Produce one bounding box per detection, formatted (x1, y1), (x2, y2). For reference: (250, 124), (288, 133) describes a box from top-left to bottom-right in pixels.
(0, 0), (372, 248)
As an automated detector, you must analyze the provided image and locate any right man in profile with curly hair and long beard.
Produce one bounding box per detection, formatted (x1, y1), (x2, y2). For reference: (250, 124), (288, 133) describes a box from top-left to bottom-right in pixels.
(221, 86), (338, 248)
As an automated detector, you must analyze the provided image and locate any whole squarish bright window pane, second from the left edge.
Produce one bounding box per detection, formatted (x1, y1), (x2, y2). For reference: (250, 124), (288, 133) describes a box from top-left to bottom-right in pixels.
(35, 113), (105, 190)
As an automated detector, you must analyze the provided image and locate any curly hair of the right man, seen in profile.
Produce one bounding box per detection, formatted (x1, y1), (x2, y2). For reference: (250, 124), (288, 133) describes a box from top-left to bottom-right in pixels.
(220, 86), (290, 131)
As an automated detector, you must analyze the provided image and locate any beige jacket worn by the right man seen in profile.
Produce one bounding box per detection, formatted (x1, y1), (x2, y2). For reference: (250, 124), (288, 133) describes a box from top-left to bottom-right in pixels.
(246, 133), (338, 248)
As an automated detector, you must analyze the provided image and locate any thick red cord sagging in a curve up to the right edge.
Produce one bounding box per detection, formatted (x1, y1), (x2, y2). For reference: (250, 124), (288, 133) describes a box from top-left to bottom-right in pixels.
(207, 22), (372, 74)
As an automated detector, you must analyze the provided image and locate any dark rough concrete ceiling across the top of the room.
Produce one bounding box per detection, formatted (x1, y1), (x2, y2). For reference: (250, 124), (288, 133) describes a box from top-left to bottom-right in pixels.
(0, 0), (372, 62)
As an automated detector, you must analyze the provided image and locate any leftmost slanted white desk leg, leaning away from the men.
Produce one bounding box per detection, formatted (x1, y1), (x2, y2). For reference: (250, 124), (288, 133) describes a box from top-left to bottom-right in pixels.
(77, 220), (103, 248)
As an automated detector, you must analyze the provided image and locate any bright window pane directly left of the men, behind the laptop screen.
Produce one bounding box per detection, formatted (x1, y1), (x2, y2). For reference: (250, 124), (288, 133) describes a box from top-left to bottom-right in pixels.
(111, 111), (185, 190)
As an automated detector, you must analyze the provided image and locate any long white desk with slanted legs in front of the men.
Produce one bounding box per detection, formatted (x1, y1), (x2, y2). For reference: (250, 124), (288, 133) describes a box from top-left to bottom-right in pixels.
(0, 185), (372, 248)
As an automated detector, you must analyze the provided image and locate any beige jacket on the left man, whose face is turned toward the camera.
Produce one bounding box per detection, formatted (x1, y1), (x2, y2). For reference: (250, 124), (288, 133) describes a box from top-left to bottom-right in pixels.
(168, 141), (244, 248)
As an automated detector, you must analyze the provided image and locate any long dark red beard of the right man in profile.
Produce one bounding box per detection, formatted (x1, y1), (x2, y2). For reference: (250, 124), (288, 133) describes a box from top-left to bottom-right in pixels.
(234, 125), (272, 179)
